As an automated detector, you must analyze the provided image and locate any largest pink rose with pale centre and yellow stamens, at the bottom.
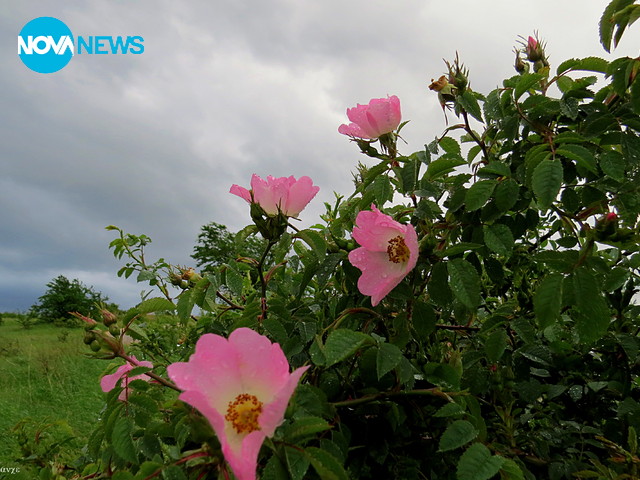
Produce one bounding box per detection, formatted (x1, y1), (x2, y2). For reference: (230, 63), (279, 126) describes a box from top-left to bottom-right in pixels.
(167, 328), (309, 480)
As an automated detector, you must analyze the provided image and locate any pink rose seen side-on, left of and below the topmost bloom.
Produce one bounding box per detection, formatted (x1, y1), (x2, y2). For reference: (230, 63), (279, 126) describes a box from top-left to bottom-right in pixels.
(229, 174), (320, 217)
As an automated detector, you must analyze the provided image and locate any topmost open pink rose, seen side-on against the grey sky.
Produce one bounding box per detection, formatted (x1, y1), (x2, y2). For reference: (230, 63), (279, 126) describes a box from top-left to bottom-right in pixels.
(338, 95), (402, 140)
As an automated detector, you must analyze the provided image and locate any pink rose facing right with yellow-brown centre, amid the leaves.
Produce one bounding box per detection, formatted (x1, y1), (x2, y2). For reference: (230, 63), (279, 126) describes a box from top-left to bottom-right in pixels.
(349, 205), (418, 306)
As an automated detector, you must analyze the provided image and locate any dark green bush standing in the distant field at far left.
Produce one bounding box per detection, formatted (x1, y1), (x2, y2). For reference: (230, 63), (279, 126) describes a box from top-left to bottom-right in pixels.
(31, 275), (107, 323)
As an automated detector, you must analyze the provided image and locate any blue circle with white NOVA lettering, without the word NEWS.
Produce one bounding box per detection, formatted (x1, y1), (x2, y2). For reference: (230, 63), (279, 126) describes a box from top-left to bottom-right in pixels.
(18, 17), (74, 73)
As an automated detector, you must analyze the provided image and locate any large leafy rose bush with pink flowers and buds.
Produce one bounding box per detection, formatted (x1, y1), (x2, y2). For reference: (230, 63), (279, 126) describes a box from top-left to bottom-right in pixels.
(16, 0), (640, 480)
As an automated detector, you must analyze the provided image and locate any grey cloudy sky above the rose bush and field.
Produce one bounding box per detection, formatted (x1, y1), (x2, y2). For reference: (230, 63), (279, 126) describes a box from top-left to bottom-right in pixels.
(0, 0), (640, 311)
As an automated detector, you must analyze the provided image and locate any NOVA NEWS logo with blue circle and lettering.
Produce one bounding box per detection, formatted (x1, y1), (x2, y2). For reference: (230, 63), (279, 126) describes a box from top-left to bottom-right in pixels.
(18, 17), (144, 73)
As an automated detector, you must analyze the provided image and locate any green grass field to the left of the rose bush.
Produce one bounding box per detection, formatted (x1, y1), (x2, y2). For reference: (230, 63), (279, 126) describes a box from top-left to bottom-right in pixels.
(0, 315), (109, 480)
